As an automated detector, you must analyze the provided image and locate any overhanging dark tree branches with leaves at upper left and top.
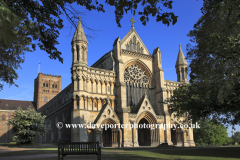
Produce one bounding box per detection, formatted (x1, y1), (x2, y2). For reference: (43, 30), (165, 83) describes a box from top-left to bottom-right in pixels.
(0, 0), (177, 90)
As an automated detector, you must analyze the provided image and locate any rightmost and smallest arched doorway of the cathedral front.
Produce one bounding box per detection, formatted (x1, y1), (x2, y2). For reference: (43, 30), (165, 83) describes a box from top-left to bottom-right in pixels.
(171, 123), (182, 145)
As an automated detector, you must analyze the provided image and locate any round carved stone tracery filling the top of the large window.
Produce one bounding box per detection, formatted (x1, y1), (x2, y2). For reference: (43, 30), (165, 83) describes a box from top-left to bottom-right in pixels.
(124, 65), (149, 84)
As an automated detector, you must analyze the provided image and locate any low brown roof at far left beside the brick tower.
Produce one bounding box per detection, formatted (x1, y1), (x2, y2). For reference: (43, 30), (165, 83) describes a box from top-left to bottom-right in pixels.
(0, 99), (35, 110)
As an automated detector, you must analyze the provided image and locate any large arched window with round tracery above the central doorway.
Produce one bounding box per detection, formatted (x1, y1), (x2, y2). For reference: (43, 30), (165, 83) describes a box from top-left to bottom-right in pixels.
(124, 65), (149, 107)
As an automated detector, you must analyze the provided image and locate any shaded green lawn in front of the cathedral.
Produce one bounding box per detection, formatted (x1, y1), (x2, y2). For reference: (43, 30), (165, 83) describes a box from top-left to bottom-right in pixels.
(0, 144), (240, 160)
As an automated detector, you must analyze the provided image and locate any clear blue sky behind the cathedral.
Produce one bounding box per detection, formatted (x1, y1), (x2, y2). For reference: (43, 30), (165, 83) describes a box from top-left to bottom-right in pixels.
(0, 0), (240, 135)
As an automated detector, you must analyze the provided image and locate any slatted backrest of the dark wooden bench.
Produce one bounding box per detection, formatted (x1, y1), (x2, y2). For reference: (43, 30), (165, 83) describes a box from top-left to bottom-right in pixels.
(58, 141), (101, 154)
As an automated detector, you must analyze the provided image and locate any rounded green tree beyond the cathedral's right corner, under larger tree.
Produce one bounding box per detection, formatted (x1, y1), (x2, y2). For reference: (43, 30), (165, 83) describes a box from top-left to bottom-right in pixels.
(193, 119), (231, 146)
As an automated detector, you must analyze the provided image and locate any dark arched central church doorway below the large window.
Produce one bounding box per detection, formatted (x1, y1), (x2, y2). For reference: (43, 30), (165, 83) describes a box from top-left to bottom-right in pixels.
(138, 118), (151, 146)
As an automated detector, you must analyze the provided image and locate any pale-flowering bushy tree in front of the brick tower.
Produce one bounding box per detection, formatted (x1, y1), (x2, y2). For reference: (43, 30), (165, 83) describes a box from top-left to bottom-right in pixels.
(8, 107), (48, 144)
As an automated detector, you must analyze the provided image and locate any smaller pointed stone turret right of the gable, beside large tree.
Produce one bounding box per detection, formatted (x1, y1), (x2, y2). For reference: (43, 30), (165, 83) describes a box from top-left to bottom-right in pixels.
(175, 44), (188, 83)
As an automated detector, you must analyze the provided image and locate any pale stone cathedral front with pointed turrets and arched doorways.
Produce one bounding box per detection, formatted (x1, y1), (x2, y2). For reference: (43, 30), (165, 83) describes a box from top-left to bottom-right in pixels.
(37, 18), (195, 147)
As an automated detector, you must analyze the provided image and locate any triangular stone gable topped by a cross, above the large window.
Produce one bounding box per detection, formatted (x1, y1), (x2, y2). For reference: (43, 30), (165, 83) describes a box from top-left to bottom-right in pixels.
(120, 28), (150, 55)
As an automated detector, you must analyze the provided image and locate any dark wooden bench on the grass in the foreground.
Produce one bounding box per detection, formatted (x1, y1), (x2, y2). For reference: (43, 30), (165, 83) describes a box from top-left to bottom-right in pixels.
(58, 141), (101, 160)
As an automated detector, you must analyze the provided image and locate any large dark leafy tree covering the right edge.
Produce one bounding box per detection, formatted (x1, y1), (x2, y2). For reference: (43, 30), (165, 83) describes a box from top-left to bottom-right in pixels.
(171, 0), (240, 125)
